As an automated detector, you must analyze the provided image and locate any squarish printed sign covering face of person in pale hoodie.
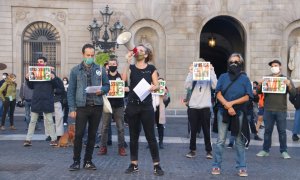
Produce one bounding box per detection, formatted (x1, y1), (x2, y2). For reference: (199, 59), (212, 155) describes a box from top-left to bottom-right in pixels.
(193, 62), (210, 81)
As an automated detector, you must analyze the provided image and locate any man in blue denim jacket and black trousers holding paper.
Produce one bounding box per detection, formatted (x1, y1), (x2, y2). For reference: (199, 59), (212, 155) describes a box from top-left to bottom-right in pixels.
(67, 44), (110, 171)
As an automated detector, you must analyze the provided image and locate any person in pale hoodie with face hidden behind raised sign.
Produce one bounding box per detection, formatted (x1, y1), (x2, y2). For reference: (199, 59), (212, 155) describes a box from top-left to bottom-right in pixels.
(185, 62), (217, 159)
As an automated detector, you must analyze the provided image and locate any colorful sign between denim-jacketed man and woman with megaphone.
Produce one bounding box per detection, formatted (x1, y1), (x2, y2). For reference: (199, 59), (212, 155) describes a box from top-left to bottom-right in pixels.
(107, 80), (125, 98)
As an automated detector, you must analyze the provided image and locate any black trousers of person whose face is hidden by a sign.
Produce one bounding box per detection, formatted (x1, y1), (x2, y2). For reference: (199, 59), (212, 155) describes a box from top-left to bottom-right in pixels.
(188, 108), (212, 152)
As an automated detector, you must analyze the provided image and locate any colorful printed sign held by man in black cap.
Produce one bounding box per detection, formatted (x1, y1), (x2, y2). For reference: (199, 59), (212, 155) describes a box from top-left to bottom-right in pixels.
(262, 76), (286, 94)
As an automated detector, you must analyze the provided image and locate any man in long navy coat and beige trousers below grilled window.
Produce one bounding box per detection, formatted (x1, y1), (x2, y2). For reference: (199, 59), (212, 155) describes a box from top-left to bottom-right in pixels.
(24, 57), (58, 147)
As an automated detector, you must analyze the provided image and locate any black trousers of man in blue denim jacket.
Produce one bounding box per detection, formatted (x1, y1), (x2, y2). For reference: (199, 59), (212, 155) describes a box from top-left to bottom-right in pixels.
(73, 106), (103, 161)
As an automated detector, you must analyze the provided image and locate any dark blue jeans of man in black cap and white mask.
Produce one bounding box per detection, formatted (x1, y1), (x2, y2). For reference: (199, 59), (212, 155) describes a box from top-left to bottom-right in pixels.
(263, 110), (287, 153)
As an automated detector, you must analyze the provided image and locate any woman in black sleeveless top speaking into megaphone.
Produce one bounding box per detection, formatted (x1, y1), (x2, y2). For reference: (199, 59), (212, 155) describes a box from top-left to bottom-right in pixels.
(122, 45), (164, 176)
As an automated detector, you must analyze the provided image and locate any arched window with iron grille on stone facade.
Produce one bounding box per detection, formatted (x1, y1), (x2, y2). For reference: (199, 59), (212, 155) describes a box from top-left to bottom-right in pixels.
(22, 21), (61, 76)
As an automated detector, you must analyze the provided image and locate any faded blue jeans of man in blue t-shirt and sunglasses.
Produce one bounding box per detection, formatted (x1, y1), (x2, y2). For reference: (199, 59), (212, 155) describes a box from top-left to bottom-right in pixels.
(213, 111), (246, 169)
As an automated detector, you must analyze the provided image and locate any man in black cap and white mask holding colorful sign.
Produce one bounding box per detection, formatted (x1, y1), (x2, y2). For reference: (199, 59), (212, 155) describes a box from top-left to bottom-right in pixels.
(256, 59), (296, 159)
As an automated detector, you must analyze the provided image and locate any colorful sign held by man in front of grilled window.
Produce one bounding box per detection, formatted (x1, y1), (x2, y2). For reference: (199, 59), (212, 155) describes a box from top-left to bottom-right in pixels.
(28, 66), (51, 81)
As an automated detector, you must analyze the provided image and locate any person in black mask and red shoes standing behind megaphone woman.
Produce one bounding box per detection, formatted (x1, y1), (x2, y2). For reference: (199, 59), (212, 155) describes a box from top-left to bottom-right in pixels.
(98, 58), (129, 156)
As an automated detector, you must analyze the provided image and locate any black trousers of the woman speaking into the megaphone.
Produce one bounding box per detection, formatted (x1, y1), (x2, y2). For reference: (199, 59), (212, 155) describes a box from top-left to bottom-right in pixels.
(126, 103), (159, 162)
